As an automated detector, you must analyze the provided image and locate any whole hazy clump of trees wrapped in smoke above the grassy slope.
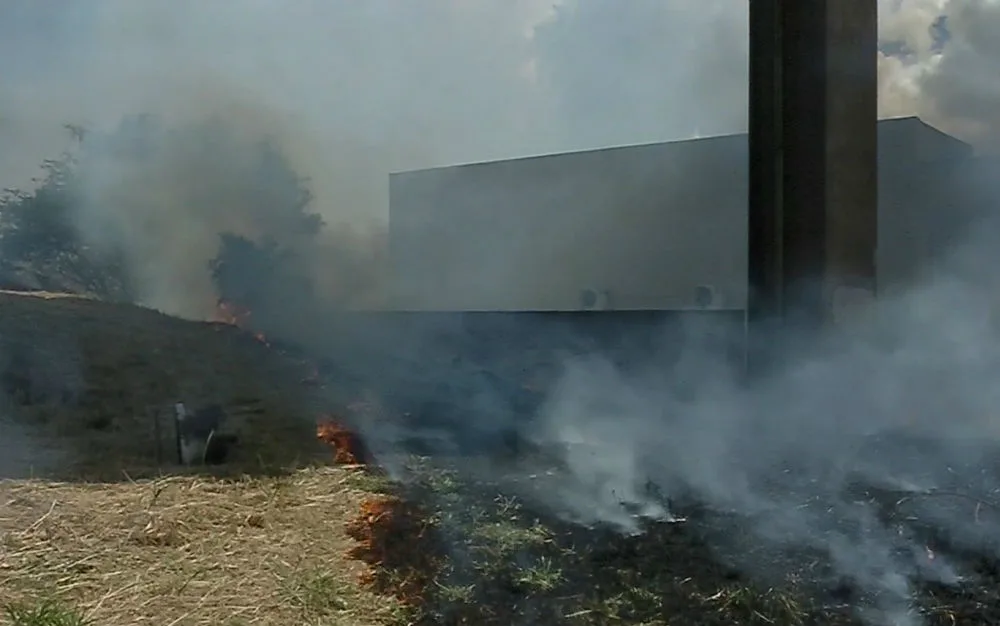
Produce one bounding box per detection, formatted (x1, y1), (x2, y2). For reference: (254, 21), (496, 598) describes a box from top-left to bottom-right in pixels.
(0, 115), (346, 325)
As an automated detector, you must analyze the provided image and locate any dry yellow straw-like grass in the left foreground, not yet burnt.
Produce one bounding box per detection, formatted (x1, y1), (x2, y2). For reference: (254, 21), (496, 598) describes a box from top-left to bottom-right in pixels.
(0, 468), (399, 626)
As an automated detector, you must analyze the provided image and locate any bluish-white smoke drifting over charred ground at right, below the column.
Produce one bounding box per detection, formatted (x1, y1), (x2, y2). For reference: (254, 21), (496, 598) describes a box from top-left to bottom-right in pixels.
(486, 224), (1000, 623)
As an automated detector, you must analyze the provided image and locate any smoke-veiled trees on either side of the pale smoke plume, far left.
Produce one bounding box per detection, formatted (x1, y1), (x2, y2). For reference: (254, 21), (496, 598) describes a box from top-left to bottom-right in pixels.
(0, 115), (324, 315)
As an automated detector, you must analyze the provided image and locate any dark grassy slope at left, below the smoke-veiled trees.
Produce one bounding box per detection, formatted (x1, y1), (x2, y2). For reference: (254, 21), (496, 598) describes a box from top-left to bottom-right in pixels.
(0, 292), (335, 480)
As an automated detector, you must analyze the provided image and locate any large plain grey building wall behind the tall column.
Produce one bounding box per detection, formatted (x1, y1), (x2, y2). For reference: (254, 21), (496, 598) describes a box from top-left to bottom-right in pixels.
(390, 117), (992, 311)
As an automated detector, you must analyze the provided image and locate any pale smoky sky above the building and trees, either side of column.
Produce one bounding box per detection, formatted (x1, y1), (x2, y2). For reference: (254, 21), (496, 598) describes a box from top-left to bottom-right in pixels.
(0, 0), (1000, 316)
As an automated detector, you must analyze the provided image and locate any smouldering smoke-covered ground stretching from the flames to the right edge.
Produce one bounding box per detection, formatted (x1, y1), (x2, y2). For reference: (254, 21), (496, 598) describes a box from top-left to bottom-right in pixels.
(336, 206), (1000, 624)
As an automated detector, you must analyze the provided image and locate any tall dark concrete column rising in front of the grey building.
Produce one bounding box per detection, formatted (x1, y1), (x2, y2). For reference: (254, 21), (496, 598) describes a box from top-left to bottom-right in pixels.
(747, 0), (878, 368)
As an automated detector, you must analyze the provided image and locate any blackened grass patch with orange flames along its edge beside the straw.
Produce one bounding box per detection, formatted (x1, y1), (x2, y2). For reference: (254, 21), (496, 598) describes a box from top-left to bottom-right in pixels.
(338, 459), (788, 626)
